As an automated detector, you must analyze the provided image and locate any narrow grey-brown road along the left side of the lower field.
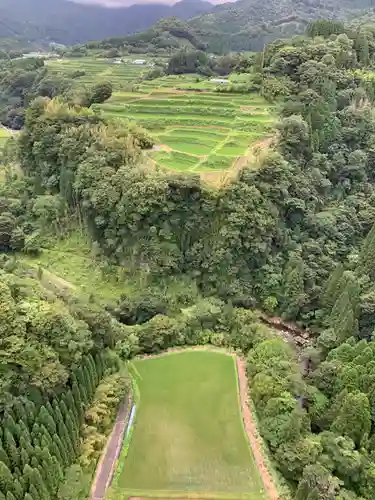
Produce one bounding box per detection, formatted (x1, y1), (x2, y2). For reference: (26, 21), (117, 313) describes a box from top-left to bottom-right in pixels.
(90, 398), (130, 500)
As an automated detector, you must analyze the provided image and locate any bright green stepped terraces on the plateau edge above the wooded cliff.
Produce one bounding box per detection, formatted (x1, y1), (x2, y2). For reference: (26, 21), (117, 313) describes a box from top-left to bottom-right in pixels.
(98, 81), (276, 177)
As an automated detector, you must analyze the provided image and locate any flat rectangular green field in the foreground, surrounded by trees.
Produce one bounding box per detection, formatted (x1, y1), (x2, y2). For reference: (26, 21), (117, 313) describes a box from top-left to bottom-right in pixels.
(109, 351), (265, 500)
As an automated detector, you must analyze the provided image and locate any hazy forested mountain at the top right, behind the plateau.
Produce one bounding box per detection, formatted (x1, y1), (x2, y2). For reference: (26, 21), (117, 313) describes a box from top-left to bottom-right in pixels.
(188, 0), (375, 52)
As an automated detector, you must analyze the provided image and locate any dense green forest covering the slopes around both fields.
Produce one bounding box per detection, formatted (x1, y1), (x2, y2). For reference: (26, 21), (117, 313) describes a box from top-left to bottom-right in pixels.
(5, 13), (375, 500)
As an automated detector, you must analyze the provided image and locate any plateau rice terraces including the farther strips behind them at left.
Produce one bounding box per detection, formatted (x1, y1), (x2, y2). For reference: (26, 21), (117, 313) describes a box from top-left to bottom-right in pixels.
(48, 56), (277, 180)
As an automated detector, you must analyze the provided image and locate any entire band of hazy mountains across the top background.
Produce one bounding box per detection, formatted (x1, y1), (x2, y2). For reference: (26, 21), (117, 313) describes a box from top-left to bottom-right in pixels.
(0, 0), (373, 53)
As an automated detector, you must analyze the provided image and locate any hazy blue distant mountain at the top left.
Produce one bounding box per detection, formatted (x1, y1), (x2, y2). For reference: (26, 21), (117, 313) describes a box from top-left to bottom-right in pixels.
(0, 0), (212, 45)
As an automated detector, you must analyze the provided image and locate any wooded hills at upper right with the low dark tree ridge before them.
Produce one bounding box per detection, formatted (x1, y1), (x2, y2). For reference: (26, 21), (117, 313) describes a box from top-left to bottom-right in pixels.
(82, 0), (373, 54)
